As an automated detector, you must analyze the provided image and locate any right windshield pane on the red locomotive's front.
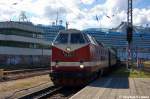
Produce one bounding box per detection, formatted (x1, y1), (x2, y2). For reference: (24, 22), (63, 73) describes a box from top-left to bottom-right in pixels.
(70, 33), (85, 44)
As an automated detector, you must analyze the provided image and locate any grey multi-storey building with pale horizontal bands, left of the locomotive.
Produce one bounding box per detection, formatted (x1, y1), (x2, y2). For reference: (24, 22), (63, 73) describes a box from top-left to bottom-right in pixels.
(0, 21), (51, 68)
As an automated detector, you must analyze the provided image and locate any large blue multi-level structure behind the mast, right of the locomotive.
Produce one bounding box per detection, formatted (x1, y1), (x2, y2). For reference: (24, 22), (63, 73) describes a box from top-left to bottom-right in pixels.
(83, 22), (150, 60)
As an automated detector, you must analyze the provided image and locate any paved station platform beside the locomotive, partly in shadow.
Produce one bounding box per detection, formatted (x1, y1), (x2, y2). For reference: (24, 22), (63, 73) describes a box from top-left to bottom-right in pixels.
(70, 77), (150, 99)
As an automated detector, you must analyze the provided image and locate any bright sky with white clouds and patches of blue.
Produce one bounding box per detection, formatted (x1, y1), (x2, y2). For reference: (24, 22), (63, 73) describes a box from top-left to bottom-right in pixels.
(0, 0), (150, 29)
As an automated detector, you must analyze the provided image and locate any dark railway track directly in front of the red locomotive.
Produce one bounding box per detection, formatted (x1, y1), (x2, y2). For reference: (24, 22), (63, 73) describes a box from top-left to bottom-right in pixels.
(12, 86), (81, 99)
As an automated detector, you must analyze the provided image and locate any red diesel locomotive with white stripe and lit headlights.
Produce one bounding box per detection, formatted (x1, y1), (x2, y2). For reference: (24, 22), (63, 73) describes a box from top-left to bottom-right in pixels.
(50, 29), (116, 86)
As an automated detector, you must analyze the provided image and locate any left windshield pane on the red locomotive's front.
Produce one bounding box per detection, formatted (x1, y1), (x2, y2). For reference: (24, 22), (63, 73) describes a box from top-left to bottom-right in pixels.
(55, 34), (68, 44)
